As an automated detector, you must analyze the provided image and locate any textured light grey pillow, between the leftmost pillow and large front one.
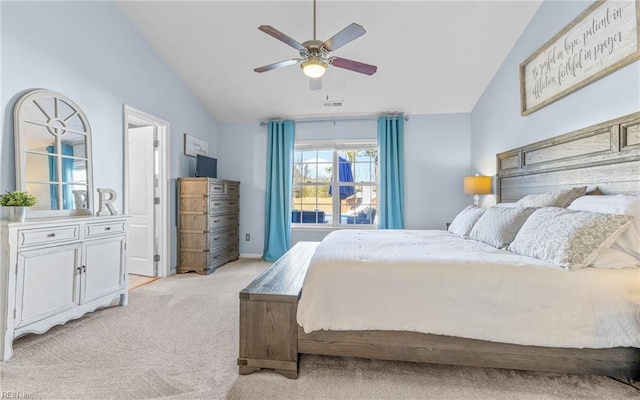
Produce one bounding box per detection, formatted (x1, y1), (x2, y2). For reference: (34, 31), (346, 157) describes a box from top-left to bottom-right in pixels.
(469, 207), (536, 249)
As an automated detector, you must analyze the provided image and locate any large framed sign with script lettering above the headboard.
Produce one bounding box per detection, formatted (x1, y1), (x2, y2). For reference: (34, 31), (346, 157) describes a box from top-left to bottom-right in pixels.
(520, 0), (640, 115)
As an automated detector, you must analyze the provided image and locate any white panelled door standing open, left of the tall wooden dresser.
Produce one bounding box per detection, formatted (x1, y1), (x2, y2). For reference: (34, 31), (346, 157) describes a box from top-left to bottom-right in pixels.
(127, 126), (157, 276)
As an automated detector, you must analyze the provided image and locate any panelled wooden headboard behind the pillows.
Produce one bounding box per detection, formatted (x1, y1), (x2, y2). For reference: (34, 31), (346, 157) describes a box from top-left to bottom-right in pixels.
(496, 112), (640, 202)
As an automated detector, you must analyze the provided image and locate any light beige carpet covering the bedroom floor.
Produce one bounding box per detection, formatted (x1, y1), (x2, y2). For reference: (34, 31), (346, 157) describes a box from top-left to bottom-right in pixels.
(0, 260), (640, 400)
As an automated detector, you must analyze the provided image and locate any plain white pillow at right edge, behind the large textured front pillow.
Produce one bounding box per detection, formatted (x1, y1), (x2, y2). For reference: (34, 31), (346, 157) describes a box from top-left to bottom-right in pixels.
(567, 194), (640, 261)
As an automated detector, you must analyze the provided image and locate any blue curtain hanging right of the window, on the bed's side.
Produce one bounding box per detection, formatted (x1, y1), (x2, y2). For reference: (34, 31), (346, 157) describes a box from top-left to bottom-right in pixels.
(378, 115), (404, 229)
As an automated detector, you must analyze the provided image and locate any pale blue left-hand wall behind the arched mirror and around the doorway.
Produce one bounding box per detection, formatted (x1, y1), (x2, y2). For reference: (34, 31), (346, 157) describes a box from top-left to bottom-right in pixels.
(0, 1), (217, 267)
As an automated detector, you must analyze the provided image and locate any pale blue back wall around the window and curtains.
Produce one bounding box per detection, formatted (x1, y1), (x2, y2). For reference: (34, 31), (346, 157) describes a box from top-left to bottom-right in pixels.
(218, 114), (471, 255)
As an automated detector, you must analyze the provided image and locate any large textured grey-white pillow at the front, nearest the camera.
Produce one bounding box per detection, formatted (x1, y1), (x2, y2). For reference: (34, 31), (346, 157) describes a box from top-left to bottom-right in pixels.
(509, 207), (633, 269)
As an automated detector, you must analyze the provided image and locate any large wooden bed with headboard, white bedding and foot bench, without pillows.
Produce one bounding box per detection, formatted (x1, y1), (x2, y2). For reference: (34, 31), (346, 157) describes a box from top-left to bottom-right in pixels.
(238, 113), (640, 379)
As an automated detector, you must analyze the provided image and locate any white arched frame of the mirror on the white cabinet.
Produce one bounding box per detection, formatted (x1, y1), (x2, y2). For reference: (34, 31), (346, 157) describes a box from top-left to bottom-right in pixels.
(13, 89), (95, 218)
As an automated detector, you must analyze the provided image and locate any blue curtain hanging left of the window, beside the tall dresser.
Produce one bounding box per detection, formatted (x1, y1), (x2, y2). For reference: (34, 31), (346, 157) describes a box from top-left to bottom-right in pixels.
(263, 121), (295, 261)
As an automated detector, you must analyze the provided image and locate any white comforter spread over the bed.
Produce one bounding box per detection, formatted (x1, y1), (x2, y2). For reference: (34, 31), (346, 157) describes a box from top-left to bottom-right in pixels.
(297, 230), (640, 348)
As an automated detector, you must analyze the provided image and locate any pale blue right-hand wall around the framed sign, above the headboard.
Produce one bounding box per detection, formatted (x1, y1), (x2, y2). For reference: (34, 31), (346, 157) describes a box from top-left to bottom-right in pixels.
(471, 1), (640, 205)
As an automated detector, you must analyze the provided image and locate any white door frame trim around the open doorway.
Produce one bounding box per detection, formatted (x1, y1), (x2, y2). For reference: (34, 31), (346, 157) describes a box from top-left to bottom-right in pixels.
(123, 104), (171, 277)
